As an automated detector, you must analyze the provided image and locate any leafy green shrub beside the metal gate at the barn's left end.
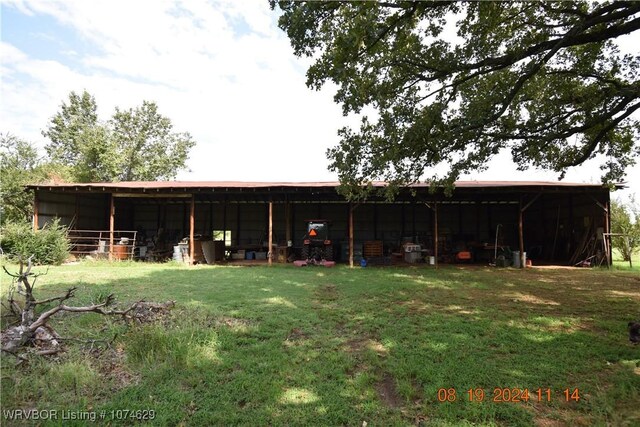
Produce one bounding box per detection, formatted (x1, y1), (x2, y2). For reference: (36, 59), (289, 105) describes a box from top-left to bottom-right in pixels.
(0, 219), (70, 265)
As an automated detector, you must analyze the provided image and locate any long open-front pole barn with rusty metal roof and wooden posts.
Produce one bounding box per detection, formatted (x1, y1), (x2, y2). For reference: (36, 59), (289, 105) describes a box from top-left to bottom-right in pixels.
(29, 181), (611, 267)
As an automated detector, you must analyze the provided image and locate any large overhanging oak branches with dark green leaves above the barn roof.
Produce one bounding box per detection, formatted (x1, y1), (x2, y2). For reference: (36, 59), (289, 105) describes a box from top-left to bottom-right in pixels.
(271, 0), (640, 201)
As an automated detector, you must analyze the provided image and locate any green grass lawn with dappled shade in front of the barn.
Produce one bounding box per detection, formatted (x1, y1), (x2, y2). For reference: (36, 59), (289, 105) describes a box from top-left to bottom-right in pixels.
(1, 263), (640, 426)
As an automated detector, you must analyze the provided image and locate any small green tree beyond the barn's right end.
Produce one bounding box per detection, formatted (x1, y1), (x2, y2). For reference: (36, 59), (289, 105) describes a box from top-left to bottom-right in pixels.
(611, 197), (640, 261)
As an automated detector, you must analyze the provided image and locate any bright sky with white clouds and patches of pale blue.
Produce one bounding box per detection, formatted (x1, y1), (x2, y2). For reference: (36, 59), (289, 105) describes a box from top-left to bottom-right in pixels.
(0, 0), (640, 198)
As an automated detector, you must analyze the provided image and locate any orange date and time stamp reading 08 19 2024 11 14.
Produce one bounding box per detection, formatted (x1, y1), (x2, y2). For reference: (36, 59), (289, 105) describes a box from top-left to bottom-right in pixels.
(438, 387), (580, 403)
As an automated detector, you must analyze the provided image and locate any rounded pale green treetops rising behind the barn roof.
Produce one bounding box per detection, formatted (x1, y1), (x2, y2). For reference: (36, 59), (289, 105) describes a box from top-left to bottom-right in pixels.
(43, 91), (195, 182)
